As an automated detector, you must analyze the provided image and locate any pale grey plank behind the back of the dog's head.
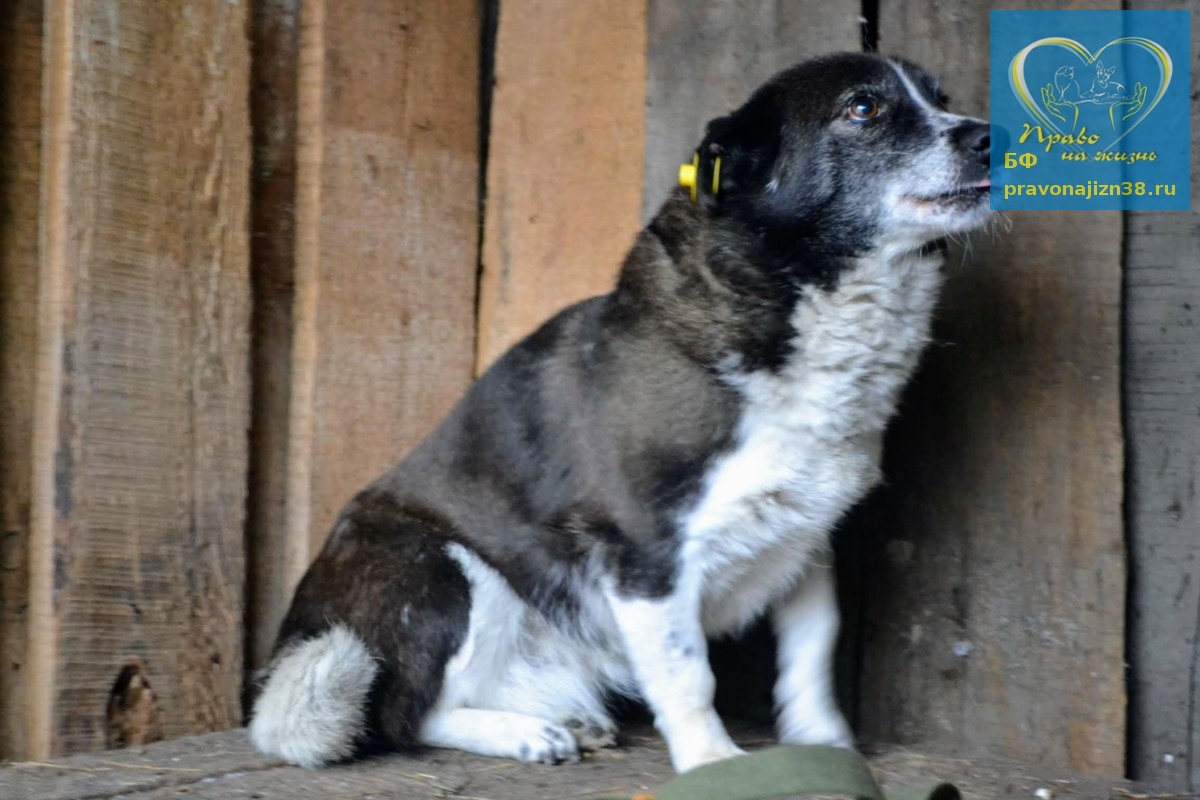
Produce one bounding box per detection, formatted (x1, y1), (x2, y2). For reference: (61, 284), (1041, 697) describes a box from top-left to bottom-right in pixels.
(643, 0), (862, 219)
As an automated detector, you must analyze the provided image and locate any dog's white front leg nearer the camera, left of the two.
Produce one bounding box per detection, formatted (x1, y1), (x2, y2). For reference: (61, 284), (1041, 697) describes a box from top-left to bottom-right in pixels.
(608, 578), (743, 772)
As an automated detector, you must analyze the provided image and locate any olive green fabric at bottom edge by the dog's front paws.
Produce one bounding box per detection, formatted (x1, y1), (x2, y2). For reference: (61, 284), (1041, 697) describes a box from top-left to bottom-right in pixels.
(592, 745), (962, 800)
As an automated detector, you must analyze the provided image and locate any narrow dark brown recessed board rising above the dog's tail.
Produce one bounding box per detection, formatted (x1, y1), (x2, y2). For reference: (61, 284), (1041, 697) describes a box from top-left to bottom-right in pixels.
(246, 0), (300, 674)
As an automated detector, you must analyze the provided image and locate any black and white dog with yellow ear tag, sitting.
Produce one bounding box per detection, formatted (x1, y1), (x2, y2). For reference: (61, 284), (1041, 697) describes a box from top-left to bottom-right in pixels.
(251, 54), (990, 771)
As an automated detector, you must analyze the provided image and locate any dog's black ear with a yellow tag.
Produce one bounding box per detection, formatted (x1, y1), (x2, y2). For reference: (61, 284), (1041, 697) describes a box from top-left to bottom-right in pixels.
(697, 92), (782, 207)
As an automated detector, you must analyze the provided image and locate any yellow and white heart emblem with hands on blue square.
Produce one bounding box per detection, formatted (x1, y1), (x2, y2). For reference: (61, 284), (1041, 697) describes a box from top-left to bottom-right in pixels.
(1008, 36), (1172, 152)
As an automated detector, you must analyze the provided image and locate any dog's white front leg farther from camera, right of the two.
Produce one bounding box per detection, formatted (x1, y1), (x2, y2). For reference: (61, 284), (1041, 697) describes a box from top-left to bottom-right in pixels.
(772, 565), (854, 747)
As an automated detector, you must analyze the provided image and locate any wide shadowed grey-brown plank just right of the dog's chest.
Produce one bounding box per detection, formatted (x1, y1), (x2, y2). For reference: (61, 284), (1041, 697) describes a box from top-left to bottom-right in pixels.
(860, 0), (1126, 775)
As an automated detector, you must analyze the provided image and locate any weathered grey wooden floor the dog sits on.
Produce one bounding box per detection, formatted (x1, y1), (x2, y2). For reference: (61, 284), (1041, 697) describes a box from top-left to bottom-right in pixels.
(0, 729), (1147, 800)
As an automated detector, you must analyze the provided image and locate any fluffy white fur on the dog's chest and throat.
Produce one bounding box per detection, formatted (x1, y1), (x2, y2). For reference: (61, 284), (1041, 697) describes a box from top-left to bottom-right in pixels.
(680, 247), (941, 633)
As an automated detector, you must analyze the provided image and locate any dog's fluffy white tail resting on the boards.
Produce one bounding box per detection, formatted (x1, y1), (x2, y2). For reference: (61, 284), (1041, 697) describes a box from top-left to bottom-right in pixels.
(243, 625), (379, 768)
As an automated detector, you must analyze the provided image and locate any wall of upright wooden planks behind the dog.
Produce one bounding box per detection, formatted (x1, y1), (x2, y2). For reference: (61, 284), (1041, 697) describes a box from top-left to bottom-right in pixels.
(0, 0), (1200, 788)
